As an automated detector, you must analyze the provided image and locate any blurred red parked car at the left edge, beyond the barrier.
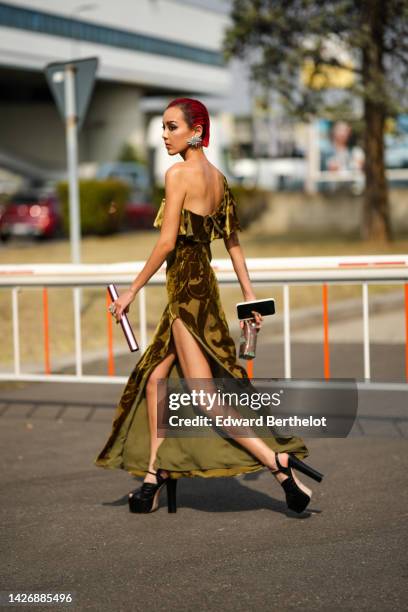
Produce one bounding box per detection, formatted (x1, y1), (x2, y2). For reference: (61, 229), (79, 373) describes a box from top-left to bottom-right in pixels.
(0, 191), (61, 241)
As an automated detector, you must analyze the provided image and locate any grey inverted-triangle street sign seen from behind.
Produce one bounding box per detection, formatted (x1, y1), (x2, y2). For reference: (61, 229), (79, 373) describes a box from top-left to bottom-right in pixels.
(45, 57), (98, 132)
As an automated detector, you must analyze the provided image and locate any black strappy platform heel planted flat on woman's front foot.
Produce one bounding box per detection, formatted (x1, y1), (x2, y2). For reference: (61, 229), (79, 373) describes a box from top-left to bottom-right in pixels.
(129, 470), (177, 514)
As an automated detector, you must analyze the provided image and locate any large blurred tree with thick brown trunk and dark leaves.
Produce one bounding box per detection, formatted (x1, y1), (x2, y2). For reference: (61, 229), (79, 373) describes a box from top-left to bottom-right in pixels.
(223, 0), (408, 241)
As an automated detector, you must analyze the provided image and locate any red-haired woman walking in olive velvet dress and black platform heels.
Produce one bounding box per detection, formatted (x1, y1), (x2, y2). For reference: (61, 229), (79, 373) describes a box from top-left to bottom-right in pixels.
(95, 98), (322, 513)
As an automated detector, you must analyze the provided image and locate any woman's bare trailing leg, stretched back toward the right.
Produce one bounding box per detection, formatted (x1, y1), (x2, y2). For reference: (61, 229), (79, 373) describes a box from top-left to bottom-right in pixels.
(169, 318), (302, 482)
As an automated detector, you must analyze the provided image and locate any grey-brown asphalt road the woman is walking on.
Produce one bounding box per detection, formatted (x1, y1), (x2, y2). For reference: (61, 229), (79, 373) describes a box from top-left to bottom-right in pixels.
(0, 354), (408, 612)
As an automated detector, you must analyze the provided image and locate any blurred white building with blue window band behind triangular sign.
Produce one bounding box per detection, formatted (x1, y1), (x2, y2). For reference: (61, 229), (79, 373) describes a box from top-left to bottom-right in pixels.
(0, 0), (255, 186)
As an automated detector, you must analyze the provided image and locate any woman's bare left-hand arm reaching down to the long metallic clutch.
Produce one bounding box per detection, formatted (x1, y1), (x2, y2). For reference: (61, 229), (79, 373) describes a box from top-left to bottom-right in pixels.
(108, 162), (186, 322)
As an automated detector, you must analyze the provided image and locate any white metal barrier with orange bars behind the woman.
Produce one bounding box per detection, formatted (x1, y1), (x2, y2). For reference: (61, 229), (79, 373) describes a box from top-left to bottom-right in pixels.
(0, 255), (408, 383)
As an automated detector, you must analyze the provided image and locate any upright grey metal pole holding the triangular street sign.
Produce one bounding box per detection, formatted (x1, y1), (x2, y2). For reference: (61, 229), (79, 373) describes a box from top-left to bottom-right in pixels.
(65, 64), (81, 263)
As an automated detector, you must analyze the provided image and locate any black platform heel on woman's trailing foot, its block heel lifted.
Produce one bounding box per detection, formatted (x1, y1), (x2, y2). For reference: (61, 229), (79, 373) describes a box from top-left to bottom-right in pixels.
(271, 453), (323, 514)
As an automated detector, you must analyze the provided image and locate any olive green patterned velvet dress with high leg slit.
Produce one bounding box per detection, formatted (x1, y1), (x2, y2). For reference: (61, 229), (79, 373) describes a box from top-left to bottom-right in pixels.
(95, 177), (308, 478)
